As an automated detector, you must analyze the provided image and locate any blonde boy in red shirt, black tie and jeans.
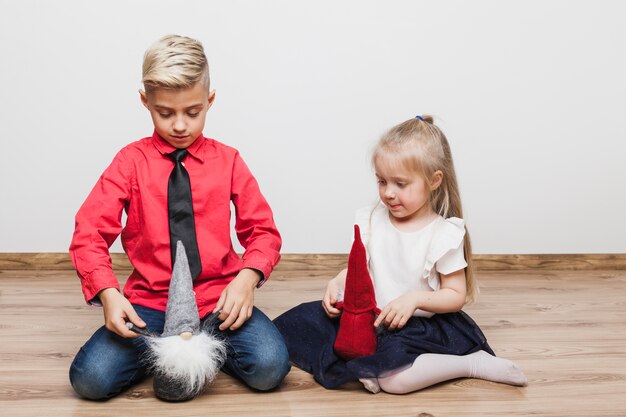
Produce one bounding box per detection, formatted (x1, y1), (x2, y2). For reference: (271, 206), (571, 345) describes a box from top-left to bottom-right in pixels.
(70, 35), (290, 399)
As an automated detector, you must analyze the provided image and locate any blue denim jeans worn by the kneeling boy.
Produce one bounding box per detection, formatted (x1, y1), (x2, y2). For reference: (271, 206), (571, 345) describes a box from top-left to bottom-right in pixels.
(70, 305), (291, 400)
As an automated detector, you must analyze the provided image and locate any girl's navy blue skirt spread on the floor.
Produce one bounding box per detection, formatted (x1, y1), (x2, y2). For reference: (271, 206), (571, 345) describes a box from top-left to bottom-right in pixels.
(274, 301), (494, 389)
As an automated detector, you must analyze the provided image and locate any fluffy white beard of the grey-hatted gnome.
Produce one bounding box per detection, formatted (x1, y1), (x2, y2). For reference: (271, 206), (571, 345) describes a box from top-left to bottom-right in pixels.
(145, 332), (227, 397)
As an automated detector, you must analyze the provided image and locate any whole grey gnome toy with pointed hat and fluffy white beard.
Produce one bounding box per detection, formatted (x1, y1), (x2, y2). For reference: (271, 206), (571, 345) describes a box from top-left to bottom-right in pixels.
(133, 241), (226, 401)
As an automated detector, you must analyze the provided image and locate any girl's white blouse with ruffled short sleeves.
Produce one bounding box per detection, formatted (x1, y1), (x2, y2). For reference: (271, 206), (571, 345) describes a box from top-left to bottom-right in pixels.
(356, 202), (467, 317)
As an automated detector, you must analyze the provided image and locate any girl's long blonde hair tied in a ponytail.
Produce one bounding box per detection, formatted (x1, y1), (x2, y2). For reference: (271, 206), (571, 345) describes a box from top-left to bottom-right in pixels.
(372, 116), (478, 303)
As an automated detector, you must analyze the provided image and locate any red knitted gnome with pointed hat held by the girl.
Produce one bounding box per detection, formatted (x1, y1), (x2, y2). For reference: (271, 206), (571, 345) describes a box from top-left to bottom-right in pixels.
(334, 225), (380, 360)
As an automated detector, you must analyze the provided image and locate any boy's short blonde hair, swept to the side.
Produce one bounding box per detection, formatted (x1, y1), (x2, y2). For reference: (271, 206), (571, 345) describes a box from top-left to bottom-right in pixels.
(142, 35), (210, 92)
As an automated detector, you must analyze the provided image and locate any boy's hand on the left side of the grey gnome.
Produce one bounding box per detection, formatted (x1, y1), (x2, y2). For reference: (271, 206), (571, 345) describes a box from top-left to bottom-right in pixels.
(99, 288), (146, 338)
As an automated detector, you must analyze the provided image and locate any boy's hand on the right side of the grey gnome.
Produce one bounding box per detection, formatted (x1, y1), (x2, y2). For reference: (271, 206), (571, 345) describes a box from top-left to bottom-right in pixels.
(213, 268), (261, 331)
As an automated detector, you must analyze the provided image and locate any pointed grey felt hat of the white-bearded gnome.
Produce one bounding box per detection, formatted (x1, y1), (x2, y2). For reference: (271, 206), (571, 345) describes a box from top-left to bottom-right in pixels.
(161, 240), (200, 337)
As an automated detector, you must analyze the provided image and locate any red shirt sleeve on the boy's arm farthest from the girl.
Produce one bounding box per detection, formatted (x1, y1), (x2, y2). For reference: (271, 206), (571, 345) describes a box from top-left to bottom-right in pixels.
(69, 151), (131, 304)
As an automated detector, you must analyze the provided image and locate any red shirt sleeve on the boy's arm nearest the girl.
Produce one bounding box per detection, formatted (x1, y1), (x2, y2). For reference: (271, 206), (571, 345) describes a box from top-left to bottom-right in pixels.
(231, 153), (282, 287)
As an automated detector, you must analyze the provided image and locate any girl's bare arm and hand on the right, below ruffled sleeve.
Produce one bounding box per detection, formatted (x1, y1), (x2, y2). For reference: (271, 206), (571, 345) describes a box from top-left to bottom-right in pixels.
(374, 269), (466, 330)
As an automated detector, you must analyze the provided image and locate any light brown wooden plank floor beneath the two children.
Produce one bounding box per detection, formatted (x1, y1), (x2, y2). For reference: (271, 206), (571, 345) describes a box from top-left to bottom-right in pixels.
(0, 265), (626, 417)
